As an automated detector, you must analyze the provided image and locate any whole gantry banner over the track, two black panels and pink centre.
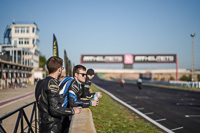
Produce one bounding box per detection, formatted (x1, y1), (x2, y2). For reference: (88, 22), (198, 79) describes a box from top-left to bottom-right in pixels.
(81, 54), (176, 65)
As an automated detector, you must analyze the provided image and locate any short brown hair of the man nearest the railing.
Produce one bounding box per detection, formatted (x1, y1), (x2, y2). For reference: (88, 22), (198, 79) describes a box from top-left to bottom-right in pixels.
(47, 56), (63, 74)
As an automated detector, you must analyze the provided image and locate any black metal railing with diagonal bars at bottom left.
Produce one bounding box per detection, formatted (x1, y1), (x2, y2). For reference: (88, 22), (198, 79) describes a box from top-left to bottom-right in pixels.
(0, 101), (38, 133)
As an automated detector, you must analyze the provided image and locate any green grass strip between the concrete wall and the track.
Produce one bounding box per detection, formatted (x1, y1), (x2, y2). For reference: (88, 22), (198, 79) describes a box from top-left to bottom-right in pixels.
(90, 85), (161, 133)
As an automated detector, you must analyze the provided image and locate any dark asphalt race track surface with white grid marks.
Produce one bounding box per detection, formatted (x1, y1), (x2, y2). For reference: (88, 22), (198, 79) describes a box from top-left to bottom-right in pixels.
(92, 76), (200, 133)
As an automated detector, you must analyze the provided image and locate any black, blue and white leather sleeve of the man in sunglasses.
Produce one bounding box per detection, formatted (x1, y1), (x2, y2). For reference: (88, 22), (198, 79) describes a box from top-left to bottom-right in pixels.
(69, 79), (92, 108)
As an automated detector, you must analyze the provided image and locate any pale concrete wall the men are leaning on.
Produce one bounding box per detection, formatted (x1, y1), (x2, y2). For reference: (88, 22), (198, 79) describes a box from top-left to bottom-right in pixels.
(69, 108), (96, 133)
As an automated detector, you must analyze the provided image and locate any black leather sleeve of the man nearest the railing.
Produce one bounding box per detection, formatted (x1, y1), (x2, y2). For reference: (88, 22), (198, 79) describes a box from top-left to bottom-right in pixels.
(47, 79), (73, 116)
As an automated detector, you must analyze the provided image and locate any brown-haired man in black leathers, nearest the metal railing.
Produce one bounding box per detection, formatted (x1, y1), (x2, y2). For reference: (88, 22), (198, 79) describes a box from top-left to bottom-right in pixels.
(35, 56), (82, 133)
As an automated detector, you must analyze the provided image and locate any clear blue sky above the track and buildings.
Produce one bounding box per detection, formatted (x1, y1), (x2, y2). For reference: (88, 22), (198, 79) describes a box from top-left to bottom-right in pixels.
(0, 0), (200, 69)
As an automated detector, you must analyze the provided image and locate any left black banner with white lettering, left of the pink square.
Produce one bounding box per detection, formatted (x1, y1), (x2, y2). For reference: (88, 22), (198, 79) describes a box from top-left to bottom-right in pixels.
(81, 55), (123, 63)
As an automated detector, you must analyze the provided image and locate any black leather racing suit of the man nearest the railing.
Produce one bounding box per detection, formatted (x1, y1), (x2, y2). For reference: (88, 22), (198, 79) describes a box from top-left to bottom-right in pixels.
(35, 76), (74, 133)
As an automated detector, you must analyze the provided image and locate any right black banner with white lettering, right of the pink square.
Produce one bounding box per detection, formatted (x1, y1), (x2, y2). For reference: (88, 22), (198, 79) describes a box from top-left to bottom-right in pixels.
(134, 54), (176, 63)
